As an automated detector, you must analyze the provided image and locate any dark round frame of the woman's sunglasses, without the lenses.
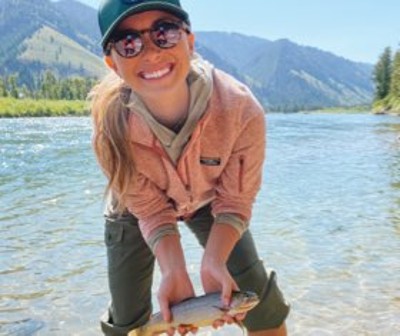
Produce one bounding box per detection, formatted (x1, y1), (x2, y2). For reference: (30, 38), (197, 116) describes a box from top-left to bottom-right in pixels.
(104, 19), (191, 58)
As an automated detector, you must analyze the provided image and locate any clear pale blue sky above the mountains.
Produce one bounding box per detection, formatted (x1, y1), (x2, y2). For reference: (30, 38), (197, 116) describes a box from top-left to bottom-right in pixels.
(79, 0), (400, 64)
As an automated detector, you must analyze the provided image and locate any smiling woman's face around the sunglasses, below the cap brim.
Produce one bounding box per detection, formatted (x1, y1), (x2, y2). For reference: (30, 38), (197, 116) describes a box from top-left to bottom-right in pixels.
(105, 11), (194, 99)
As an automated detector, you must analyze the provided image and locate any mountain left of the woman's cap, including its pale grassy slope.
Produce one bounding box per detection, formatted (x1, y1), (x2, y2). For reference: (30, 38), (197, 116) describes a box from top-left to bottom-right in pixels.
(0, 0), (104, 81)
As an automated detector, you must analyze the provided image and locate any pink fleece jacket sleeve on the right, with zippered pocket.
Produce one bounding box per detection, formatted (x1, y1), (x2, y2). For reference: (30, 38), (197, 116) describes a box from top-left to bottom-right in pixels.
(212, 100), (266, 234)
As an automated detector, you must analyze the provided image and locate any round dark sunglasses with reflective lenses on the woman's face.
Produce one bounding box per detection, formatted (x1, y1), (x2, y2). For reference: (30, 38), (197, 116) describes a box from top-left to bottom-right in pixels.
(104, 19), (190, 58)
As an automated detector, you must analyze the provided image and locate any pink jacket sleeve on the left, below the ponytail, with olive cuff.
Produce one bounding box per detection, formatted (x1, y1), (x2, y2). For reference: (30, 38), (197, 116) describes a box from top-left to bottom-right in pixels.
(126, 173), (179, 251)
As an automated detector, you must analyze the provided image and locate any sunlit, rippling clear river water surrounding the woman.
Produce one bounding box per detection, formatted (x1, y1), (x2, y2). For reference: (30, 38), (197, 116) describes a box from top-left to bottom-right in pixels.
(0, 114), (400, 336)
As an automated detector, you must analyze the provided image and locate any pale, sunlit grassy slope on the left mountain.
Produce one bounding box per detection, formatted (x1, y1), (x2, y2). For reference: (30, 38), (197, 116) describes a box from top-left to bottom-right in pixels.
(18, 26), (105, 77)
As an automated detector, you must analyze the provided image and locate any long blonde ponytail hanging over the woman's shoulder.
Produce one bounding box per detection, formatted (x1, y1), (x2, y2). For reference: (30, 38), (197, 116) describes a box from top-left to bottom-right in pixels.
(88, 71), (134, 213)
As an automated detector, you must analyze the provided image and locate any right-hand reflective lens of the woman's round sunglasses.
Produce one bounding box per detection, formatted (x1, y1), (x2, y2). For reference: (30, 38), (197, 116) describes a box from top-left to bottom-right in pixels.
(151, 21), (181, 49)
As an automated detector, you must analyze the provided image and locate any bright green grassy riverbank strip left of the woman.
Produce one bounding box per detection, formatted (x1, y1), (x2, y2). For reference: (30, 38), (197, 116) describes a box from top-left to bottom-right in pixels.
(0, 97), (89, 118)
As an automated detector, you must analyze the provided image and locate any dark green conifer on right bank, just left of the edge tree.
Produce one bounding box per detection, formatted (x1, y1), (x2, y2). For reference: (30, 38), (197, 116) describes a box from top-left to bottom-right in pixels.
(374, 47), (392, 100)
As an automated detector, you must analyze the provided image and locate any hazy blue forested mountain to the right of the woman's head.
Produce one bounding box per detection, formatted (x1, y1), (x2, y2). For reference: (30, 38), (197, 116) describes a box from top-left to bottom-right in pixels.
(198, 33), (373, 110)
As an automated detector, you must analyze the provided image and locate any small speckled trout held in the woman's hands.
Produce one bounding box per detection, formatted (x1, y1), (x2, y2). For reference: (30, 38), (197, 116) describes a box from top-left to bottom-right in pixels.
(128, 291), (259, 336)
